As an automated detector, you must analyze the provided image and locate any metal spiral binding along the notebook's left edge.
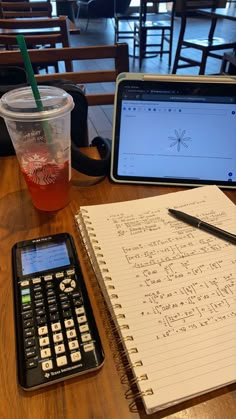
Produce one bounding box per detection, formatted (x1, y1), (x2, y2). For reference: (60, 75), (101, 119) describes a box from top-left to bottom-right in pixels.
(76, 209), (154, 412)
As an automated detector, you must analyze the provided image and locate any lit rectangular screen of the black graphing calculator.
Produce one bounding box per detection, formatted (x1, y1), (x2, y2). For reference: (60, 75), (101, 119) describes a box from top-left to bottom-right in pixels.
(21, 242), (70, 275)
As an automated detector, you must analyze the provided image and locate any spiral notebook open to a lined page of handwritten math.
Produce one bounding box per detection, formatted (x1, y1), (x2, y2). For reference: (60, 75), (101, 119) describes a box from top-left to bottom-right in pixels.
(76, 186), (236, 413)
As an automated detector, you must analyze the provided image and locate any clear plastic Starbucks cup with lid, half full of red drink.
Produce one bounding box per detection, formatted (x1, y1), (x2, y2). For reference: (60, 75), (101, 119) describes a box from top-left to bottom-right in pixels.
(0, 86), (74, 211)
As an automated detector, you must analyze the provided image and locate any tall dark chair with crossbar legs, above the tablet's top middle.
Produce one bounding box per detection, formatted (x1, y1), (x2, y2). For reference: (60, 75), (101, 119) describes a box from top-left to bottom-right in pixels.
(133, 0), (176, 68)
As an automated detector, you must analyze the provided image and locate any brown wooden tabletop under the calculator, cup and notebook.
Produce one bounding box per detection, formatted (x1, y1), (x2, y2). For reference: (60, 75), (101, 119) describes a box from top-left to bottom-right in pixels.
(0, 149), (236, 419)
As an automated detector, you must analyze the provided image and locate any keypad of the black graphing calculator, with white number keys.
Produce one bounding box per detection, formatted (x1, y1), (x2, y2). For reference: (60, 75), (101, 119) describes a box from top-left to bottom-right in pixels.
(20, 268), (99, 388)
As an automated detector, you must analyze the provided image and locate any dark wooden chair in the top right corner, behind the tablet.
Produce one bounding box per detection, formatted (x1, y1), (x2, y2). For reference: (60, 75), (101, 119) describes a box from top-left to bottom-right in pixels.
(172, 0), (236, 74)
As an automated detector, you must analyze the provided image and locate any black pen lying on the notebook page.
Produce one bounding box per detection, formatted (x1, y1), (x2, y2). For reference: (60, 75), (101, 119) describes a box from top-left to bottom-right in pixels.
(168, 208), (236, 244)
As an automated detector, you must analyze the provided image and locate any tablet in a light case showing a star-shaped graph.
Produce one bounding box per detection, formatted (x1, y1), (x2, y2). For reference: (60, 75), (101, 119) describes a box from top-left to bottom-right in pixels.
(110, 73), (236, 188)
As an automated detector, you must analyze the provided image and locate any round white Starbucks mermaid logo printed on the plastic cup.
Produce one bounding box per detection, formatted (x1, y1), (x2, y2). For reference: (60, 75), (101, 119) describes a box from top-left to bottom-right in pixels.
(21, 153), (59, 185)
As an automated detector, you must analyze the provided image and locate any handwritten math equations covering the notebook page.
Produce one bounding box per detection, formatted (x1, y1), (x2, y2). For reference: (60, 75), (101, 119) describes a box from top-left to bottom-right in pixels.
(109, 210), (236, 339)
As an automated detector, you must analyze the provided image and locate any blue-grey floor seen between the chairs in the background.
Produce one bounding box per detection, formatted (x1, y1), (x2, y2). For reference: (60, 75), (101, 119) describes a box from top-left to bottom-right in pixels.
(67, 12), (236, 140)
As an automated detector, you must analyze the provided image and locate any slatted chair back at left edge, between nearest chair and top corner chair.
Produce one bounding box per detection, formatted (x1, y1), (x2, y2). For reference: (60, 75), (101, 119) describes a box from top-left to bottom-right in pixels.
(0, 16), (72, 71)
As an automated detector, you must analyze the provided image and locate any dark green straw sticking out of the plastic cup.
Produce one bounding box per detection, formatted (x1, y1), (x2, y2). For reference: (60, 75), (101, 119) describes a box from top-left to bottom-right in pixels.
(16, 35), (52, 143)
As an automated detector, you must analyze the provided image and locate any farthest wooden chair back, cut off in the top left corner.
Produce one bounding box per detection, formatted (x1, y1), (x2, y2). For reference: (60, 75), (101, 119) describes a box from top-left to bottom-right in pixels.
(0, 0), (52, 19)
